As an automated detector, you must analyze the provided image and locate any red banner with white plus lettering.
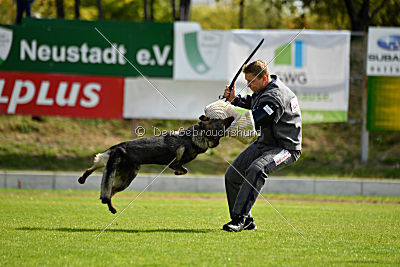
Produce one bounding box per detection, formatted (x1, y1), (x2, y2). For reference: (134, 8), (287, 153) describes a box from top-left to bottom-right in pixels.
(0, 72), (124, 119)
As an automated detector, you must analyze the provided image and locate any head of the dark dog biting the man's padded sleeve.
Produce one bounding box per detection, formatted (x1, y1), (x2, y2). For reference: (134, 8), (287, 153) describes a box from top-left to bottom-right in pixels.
(199, 115), (235, 148)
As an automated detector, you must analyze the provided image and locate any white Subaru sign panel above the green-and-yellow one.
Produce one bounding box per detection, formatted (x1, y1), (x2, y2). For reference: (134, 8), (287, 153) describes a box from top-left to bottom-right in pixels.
(367, 27), (400, 76)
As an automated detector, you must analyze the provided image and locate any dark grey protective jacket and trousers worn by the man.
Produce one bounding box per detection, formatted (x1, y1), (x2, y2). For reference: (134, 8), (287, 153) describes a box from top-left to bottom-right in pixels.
(225, 75), (302, 218)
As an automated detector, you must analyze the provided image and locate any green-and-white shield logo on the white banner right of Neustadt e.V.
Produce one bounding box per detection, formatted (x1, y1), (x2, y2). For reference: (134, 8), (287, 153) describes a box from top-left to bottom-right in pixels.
(184, 32), (222, 74)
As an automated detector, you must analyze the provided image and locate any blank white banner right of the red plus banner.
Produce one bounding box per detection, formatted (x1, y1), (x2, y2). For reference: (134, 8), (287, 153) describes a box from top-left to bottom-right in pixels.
(123, 78), (225, 120)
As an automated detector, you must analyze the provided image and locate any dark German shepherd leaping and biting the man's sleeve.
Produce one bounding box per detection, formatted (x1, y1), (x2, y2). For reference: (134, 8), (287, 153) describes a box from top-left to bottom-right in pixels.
(78, 115), (234, 214)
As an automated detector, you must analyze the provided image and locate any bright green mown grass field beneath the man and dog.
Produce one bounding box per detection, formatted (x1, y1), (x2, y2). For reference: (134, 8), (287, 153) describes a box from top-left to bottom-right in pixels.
(0, 189), (400, 266)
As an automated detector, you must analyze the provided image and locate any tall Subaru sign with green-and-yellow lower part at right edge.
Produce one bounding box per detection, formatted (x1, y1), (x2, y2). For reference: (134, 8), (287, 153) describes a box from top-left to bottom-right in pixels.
(366, 27), (400, 131)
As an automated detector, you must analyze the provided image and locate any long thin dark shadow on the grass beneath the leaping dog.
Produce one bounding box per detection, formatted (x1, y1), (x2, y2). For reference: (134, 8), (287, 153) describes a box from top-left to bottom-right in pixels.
(15, 227), (214, 234)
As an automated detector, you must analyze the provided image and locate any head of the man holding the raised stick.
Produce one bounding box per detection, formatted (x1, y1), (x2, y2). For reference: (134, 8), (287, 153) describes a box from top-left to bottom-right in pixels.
(242, 60), (271, 92)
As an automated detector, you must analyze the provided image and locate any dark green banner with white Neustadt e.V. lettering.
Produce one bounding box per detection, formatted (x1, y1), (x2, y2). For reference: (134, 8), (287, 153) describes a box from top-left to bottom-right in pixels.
(0, 19), (173, 77)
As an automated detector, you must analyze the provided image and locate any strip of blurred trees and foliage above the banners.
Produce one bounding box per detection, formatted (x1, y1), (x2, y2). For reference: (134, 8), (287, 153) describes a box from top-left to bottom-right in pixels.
(0, 0), (400, 31)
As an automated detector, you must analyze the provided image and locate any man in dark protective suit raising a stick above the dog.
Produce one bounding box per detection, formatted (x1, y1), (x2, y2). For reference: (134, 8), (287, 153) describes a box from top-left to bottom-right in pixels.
(222, 60), (302, 232)
